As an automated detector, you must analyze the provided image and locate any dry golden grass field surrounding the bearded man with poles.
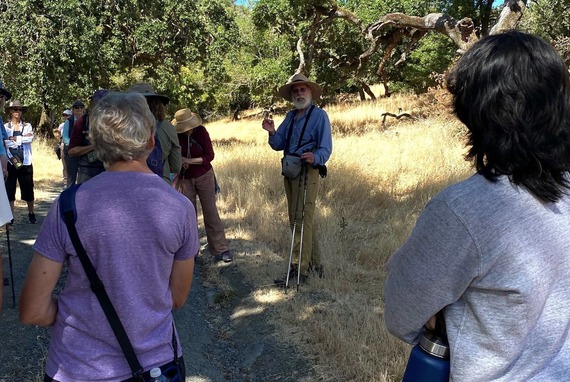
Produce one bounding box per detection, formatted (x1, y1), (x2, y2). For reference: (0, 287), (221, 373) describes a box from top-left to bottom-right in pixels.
(207, 97), (471, 381)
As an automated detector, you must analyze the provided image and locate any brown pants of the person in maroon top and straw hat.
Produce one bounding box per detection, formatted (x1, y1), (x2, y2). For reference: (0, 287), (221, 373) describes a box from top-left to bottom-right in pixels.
(180, 169), (229, 255)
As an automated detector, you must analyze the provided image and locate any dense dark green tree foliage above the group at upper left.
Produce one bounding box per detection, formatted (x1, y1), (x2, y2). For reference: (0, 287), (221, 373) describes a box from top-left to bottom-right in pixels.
(0, 0), (238, 130)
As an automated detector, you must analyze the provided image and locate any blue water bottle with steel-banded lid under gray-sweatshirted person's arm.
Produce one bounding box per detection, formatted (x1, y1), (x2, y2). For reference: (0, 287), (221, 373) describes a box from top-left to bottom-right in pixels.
(402, 314), (449, 382)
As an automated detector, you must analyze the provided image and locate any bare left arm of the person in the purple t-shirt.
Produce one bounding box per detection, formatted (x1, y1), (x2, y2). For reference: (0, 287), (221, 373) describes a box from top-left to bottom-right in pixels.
(20, 252), (63, 327)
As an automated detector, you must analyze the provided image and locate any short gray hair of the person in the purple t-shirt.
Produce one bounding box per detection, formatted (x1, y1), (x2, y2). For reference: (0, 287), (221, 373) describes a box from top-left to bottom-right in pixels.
(89, 93), (156, 166)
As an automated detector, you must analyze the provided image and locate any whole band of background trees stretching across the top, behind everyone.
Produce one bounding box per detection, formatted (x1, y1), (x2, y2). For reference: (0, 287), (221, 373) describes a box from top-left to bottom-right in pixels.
(0, 0), (570, 134)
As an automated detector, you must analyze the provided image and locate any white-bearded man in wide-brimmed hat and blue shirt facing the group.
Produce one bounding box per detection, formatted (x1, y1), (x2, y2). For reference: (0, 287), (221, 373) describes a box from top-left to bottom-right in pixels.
(262, 74), (332, 285)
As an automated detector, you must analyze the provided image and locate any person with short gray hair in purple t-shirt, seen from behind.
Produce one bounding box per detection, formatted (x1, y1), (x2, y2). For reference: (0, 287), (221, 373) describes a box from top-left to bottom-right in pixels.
(20, 93), (199, 382)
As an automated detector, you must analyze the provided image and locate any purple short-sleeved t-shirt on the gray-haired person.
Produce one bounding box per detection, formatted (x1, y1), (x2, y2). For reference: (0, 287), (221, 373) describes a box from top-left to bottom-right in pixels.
(33, 172), (199, 382)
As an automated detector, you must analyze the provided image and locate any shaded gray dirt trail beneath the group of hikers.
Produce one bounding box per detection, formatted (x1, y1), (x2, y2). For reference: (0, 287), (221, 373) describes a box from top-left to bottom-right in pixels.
(0, 184), (320, 382)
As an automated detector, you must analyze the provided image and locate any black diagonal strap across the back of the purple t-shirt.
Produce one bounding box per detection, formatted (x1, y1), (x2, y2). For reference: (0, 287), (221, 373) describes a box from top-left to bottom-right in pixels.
(59, 184), (143, 380)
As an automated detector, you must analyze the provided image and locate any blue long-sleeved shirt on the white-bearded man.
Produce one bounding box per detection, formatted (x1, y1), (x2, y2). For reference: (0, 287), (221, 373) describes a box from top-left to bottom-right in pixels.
(269, 106), (332, 165)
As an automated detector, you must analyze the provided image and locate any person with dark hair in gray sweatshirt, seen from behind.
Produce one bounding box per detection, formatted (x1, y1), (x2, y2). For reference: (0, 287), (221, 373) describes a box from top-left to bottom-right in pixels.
(385, 31), (570, 382)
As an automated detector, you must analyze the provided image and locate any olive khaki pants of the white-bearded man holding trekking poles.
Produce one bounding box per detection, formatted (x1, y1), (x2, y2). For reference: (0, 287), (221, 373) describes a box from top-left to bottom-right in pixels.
(283, 165), (321, 276)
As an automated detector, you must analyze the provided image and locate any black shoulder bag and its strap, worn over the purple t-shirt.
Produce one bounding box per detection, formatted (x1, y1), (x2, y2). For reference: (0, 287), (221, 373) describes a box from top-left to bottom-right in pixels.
(59, 184), (185, 382)
